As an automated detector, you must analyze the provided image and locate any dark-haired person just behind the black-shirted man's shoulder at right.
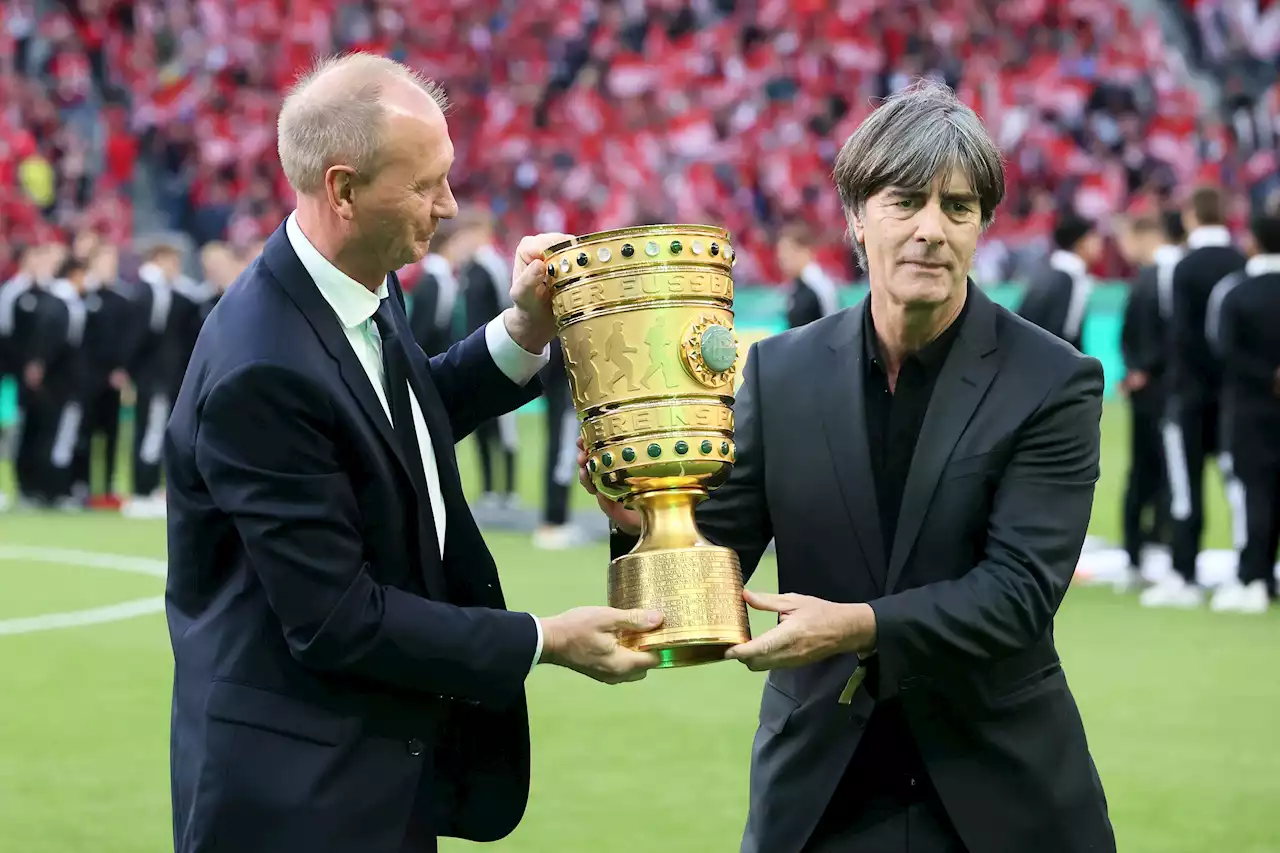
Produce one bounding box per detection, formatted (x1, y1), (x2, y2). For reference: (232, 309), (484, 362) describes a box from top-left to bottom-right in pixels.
(1018, 213), (1102, 352)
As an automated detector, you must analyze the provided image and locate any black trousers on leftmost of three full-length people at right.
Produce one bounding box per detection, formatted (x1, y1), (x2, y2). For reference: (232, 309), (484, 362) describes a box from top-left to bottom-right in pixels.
(1124, 400), (1169, 567)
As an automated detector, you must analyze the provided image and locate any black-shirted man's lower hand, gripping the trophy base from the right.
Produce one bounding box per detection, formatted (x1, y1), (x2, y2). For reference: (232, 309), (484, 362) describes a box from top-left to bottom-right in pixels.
(724, 589), (876, 671)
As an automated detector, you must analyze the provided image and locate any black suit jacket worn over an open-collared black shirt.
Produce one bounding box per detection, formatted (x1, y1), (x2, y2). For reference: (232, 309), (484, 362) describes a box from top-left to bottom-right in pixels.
(613, 286), (1115, 853)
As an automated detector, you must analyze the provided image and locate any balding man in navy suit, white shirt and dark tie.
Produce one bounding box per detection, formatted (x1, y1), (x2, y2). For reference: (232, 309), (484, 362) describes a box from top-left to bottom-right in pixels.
(164, 54), (660, 853)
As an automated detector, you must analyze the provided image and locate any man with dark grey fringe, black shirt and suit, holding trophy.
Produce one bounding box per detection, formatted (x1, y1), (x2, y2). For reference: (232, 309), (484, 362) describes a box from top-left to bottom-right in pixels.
(580, 83), (1115, 853)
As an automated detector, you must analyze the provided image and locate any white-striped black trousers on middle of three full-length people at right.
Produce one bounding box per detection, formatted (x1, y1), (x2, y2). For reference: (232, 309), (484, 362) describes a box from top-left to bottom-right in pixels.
(1162, 400), (1221, 584)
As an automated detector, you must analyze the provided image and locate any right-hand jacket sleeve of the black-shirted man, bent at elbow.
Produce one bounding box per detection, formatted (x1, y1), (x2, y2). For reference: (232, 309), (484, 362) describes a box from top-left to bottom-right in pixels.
(869, 359), (1102, 698)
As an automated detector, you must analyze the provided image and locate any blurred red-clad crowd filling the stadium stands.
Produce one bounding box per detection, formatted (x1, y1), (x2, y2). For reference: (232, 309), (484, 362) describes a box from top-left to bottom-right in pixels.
(0, 0), (1280, 283)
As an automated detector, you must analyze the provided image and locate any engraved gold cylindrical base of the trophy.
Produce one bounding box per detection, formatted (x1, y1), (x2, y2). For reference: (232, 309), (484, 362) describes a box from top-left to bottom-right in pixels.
(609, 540), (751, 669)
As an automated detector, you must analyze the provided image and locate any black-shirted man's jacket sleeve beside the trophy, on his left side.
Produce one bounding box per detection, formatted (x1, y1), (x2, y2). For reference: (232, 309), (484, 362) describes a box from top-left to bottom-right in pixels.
(609, 345), (773, 581)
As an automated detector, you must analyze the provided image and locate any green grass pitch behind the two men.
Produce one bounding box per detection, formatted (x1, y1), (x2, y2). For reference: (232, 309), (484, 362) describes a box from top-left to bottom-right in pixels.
(0, 406), (1280, 853)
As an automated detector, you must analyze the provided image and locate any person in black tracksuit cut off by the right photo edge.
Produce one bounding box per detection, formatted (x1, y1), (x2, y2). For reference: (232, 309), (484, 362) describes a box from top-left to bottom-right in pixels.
(1207, 213), (1280, 613)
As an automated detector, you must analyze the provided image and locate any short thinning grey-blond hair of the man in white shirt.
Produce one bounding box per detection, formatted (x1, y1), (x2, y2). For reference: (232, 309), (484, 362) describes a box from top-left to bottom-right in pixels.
(276, 53), (448, 195)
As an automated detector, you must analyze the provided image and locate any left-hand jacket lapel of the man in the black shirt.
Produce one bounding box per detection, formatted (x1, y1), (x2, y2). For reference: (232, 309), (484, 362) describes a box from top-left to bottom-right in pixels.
(822, 300), (886, 589)
